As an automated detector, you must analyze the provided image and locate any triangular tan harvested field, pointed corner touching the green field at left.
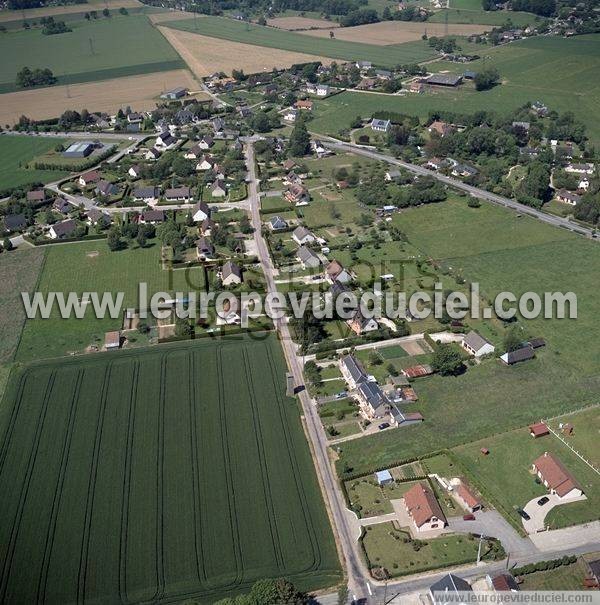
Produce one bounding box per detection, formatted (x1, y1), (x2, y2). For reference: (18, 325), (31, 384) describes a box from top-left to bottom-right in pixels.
(158, 27), (332, 78)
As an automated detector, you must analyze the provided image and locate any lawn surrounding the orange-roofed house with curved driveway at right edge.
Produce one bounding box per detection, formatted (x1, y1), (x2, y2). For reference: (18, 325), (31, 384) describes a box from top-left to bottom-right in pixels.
(452, 428), (600, 529)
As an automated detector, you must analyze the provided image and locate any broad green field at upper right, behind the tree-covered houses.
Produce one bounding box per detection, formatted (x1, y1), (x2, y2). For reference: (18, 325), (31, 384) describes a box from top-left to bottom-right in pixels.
(309, 34), (600, 143)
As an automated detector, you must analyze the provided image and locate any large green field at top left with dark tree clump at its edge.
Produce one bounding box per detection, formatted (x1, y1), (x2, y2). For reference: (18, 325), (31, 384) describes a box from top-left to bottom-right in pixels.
(0, 15), (185, 93)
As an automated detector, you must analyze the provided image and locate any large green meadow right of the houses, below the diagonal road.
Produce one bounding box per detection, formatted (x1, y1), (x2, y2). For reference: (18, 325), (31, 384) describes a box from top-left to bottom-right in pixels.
(340, 200), (600, 472)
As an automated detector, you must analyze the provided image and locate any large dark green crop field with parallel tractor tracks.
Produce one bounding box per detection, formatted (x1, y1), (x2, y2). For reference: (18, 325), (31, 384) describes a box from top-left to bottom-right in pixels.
(0, 337), (341, 605)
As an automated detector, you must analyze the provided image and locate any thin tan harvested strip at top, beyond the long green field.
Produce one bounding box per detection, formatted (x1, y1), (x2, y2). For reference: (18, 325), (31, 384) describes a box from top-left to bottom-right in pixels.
(302, 21), (490, 46)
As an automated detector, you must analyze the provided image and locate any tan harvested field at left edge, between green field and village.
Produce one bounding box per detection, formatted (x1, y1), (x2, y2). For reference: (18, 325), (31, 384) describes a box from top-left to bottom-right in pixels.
(0, 69), (203, 124)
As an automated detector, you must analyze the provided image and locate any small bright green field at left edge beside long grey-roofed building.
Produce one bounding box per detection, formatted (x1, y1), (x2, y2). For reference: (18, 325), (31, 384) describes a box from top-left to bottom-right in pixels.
(0, 134), (67, 192)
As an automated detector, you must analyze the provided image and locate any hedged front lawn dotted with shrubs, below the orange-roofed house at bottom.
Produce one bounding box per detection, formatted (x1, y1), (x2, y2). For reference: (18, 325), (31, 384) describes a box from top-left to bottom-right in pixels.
(362, 523), (489, 577)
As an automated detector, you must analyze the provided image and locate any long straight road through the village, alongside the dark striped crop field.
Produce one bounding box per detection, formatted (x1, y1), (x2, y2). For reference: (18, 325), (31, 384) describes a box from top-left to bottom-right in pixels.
(245, 139), (370, 599)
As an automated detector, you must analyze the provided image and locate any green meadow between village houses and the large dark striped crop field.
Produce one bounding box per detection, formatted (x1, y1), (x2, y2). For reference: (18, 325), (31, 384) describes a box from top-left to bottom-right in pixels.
(16, 240), (204, 361)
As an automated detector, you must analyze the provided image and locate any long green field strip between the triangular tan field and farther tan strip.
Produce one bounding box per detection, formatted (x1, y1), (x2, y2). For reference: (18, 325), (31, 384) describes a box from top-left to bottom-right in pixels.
(164, 16), (435, 67)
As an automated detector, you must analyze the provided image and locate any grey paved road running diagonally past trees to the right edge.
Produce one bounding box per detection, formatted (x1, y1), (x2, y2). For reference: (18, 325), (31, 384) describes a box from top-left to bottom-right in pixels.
(320, 137), (594, 237)
